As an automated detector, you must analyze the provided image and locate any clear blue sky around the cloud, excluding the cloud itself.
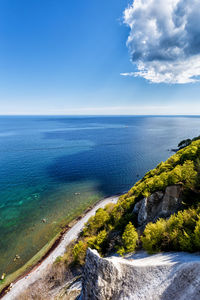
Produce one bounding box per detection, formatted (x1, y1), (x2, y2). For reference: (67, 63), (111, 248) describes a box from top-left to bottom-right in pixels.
(0, 0), (200, 115)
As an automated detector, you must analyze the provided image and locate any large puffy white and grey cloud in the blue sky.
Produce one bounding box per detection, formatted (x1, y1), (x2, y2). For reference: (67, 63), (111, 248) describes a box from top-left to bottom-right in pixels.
(122, 0), (200, 83)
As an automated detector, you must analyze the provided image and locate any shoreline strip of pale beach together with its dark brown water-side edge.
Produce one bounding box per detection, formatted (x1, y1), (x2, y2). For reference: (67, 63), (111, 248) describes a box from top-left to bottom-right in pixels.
(0, 195), (120, 300)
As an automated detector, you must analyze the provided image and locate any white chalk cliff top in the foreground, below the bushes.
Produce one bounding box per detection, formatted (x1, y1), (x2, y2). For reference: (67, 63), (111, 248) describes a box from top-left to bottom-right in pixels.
(81, 249), (200, 300)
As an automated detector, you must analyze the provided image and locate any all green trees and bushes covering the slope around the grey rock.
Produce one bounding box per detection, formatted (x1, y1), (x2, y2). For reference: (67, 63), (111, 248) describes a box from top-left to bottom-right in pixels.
(66, 138), (200, 264)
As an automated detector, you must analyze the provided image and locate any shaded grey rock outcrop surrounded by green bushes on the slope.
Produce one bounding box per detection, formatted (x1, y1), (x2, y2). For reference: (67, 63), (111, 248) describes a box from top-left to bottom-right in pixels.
(133, 185), (183, 226)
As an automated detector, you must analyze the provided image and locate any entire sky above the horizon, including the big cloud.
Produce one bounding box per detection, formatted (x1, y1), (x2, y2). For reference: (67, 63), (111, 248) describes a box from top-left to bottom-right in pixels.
(0, 0), (200, 115)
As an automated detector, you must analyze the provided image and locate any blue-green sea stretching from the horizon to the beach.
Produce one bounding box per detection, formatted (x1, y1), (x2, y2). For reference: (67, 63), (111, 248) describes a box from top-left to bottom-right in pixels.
(0, 116), (200, 274)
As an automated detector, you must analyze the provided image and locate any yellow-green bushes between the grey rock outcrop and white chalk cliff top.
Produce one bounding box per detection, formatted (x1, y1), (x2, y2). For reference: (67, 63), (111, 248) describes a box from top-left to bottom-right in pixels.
(141, 208), (200, 253)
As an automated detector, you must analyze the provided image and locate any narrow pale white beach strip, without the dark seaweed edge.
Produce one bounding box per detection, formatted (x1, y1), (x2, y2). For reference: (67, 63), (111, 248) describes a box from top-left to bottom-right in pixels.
(2, 196), (119, 300)
